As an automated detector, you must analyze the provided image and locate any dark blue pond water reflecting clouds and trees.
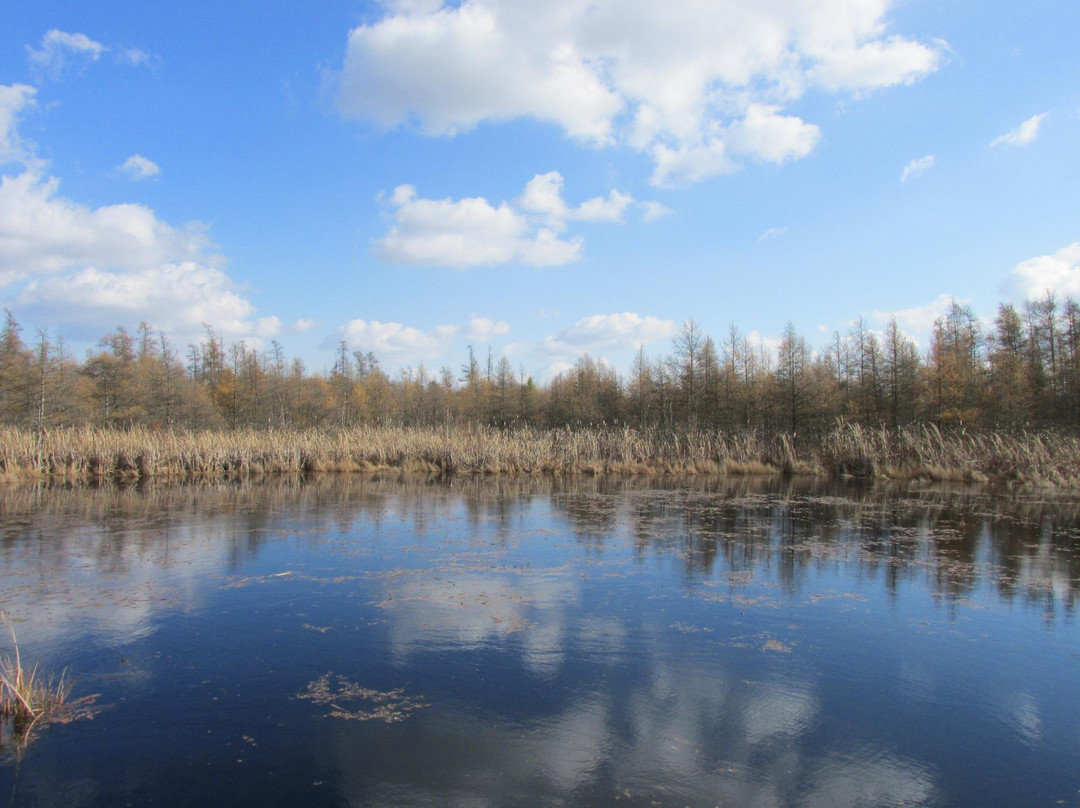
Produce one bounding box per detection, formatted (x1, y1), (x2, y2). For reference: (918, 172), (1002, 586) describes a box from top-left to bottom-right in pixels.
(0, 479), (1080, 808)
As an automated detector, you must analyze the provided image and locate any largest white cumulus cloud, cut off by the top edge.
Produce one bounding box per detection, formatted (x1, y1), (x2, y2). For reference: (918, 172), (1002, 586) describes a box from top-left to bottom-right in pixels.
(337, 0), (947, 185)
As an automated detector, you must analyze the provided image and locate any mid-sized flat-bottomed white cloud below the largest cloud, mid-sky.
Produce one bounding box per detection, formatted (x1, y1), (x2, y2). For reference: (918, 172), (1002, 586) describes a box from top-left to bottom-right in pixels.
(375, 171), (652, 268)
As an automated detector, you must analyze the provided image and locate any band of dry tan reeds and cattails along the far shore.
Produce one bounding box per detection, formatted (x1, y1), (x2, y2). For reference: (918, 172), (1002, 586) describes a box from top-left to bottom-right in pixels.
(0, 422), (1080, 486)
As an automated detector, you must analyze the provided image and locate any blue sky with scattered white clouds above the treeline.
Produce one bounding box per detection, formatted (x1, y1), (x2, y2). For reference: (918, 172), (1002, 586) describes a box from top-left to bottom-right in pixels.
(0, 0), (1080, 379)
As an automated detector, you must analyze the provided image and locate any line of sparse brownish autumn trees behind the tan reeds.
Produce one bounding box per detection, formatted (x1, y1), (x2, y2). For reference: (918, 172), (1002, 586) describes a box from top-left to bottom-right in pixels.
(0, 294), (1080, 433)
